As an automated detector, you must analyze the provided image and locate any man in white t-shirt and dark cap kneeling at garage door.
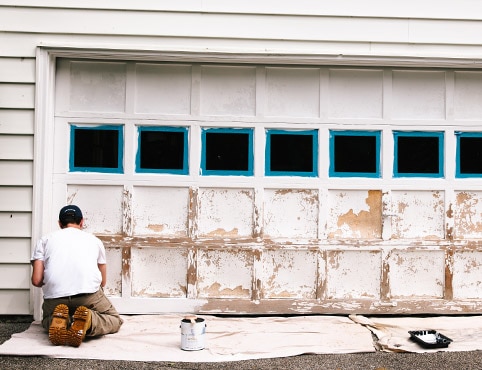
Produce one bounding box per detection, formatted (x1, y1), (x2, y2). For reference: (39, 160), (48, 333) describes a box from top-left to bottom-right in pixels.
(31, 205), (123, 347)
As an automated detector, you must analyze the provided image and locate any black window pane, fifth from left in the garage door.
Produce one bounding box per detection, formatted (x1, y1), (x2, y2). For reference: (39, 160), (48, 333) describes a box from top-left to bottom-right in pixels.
(334, 135), (377, 173)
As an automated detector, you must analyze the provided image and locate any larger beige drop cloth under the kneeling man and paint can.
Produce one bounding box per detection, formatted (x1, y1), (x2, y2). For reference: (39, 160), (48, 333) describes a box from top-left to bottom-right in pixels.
(0, 315), (375, 362)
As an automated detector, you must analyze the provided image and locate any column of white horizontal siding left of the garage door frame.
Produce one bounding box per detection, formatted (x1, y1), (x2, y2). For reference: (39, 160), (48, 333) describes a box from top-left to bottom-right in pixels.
(0, 55), (35, 314)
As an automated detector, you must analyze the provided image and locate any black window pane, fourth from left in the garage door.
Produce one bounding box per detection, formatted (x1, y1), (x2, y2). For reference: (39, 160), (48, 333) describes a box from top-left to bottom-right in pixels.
(270, 134), (313, 172)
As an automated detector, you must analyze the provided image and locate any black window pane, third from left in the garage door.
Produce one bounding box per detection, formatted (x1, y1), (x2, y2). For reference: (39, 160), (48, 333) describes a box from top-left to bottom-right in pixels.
(206, 132), (250, 171)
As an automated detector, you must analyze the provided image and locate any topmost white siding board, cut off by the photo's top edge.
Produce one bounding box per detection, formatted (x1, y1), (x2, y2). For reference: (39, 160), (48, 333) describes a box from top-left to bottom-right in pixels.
(0, 0), (481, 19)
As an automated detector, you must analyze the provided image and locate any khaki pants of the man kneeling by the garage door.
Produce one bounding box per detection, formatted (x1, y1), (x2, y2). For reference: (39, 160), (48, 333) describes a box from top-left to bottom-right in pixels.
(42, 288), (123, 337)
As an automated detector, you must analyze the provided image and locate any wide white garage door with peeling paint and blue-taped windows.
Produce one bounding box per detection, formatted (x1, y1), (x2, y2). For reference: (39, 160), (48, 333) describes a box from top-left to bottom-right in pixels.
(48, 60), (482, 314)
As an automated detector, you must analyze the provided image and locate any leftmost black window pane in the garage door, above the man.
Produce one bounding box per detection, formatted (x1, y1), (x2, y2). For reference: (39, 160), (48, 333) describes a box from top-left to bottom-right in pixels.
(74, 128), (119, 168)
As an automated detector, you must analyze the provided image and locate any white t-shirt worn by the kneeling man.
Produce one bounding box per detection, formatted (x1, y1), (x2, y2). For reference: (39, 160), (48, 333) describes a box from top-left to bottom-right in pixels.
(32, 227), (106, 298)
